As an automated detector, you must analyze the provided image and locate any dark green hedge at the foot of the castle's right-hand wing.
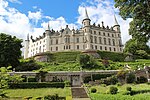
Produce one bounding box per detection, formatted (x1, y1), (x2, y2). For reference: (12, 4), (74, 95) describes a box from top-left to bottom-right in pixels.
(97, 51), (126, 61)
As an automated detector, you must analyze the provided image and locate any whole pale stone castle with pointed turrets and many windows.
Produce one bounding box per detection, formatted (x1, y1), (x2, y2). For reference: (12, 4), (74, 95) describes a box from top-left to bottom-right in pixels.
(24, 9), (123, 58)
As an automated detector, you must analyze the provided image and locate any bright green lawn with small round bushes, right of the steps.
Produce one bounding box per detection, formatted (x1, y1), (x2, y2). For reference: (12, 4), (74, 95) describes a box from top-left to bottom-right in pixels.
(90, 84), (150, 100)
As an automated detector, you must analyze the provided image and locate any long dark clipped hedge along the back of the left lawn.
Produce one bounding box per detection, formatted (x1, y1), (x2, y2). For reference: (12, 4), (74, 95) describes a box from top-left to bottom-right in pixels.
(9, 82), (65, 89)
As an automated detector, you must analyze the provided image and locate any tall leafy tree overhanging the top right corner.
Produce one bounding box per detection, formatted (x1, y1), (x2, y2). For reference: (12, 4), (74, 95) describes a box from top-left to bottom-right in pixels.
(115, 0), (150, 42)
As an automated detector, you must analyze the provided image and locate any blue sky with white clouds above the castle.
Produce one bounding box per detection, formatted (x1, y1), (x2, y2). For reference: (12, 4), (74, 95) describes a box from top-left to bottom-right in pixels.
(0, 0), (132, 44)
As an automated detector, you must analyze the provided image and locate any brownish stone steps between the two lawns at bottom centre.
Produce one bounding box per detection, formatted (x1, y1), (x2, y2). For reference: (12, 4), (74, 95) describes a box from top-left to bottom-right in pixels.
(71, 87), (90, 100)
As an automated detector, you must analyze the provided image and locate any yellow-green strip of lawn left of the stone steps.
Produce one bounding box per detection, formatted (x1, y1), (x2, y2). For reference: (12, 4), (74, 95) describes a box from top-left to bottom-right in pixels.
(5, 87), (71, 97)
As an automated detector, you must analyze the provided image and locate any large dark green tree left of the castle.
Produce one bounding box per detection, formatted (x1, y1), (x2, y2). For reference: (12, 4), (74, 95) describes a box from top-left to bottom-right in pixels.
(0, 33), (22, 68)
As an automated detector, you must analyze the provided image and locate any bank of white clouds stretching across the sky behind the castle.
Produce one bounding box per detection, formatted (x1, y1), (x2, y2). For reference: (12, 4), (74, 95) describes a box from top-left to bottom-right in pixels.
(0, 0), (131, 46)
